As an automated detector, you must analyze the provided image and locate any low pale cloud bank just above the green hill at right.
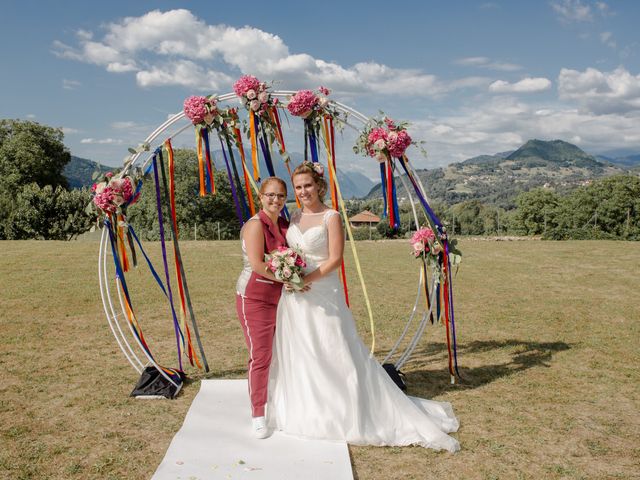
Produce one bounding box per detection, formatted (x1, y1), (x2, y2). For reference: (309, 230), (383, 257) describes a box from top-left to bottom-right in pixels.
(412, 96), (640, 168)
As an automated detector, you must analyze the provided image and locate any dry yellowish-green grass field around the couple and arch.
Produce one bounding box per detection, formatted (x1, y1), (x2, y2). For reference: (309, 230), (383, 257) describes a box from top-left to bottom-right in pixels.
(0, 240), (640, 480)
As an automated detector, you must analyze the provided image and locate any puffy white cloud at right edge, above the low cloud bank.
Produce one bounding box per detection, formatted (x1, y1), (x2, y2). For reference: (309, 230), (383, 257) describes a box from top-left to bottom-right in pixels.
(558, 67), (640, 114)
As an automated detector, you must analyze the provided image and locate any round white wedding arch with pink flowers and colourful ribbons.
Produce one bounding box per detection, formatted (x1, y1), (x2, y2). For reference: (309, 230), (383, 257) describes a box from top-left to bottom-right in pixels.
(93, 76), (460, 396)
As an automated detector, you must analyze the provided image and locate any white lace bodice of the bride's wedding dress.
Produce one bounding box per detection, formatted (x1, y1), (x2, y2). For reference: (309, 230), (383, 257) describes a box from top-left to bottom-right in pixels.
(287, 209), (339, 272)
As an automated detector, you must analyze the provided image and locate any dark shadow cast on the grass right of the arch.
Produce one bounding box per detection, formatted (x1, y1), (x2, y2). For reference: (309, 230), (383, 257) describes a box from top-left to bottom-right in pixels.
(392, 339), (571, 398)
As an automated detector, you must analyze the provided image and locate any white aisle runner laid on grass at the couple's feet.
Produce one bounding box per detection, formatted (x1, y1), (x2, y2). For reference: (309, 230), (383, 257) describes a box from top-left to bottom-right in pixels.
(152, 380), (353, 480)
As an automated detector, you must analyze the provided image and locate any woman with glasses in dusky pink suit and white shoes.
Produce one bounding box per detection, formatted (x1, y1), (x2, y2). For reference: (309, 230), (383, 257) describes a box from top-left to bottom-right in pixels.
(236, 177), (289, 438)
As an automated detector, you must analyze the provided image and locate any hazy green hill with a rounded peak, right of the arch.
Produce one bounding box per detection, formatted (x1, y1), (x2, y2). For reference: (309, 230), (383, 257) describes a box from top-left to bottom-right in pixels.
(367, 140), (624, 208)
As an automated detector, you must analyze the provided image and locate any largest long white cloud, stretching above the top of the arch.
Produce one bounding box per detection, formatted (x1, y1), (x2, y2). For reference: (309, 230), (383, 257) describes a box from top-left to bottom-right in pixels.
(53, 9), (484, 96)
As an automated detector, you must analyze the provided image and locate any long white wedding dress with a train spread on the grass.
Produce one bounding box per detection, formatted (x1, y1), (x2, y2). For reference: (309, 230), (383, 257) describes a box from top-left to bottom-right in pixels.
(267, 210), (460, 452)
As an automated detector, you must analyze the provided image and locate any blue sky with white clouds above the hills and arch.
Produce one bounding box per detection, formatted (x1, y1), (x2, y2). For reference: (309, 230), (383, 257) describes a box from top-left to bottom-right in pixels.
(0, 0), (640, 176)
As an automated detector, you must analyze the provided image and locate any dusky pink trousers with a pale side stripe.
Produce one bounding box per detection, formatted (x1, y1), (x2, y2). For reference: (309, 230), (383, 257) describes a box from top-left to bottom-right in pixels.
(236, 294), (278, 417)
